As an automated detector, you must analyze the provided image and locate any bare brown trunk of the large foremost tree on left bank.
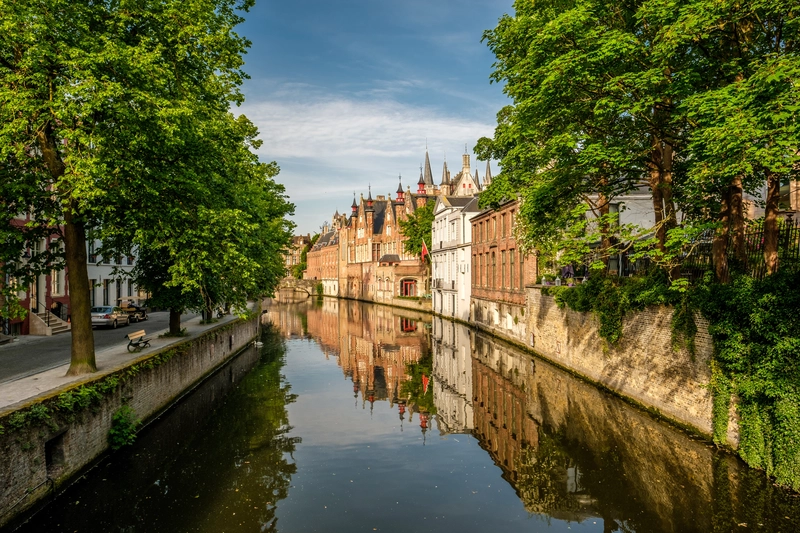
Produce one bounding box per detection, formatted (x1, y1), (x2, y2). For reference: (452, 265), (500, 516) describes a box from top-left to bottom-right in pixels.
(37, 125), (97, 376)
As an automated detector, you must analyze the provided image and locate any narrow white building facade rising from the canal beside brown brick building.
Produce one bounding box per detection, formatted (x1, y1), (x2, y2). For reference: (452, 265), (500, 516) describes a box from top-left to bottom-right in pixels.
(430, 196), (478, 321)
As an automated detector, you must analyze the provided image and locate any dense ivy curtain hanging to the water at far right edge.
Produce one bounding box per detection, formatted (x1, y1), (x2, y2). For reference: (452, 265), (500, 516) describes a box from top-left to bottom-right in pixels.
(693, 272), (800, 490)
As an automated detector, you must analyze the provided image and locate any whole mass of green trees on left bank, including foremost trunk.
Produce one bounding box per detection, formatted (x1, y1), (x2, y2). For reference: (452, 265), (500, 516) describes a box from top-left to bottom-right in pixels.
(0, 0), (291, 373)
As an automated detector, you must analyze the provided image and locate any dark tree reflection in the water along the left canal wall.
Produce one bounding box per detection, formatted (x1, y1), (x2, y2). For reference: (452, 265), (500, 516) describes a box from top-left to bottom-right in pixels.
(13, 331), (299, 532)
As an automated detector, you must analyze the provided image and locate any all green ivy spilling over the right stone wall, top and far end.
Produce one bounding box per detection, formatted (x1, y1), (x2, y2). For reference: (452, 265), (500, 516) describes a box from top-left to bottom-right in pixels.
(542, 271), (800, 490)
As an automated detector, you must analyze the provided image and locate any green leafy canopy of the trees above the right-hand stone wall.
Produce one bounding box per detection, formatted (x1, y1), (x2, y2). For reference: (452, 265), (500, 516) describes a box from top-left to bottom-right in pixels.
(476, 0), (800, 278)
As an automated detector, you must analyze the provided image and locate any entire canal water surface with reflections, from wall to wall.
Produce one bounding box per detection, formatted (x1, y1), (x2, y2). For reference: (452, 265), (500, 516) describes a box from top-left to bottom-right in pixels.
(9, 299), (800, 533)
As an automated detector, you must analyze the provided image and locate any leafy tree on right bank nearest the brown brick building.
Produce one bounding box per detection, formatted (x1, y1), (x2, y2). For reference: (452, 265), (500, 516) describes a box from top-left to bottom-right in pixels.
(476, 0), (678, 272)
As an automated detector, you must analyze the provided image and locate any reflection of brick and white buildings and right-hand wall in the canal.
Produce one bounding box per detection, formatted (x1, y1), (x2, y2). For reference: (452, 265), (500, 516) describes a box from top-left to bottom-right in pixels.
(270, 299), (800, 532)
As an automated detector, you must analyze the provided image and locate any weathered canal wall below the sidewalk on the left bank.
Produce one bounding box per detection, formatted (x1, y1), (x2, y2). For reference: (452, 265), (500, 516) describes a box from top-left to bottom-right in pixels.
(0, 317), (259, 527)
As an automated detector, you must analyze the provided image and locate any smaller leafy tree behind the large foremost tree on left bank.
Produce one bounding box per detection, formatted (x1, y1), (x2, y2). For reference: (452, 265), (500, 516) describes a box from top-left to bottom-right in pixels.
(128, 112), (294, 334)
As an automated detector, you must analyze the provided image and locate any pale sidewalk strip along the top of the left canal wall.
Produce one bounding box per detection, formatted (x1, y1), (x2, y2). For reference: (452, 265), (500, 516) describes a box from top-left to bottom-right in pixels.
(0, 315), (241, 415)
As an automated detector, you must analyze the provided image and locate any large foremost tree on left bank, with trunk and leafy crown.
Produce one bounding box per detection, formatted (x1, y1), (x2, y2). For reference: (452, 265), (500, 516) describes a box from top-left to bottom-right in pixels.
(0, 0), (251, 374)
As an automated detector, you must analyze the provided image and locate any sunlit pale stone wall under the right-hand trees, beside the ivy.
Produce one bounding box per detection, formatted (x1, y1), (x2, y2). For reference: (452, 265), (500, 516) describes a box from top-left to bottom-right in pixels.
(526, 288), (738, 440)
